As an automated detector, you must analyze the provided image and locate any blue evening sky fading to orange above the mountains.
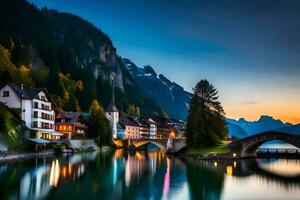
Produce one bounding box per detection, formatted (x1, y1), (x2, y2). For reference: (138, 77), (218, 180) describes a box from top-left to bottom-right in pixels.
(30, 0), (300, 124)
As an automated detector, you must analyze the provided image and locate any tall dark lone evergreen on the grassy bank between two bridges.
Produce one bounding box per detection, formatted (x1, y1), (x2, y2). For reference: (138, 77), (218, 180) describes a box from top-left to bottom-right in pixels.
(186, 80), (227, 147)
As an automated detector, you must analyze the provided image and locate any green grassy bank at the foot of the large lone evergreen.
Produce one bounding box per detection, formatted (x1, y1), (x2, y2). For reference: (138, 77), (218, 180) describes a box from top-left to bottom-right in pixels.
(185, 141), (228, 157)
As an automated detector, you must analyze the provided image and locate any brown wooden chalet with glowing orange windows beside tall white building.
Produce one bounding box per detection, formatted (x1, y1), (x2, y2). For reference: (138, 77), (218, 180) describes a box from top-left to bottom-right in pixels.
(55, 112), (87, 139)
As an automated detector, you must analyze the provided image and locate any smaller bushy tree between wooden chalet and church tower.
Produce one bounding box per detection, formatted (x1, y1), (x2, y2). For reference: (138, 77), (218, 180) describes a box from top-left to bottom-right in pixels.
(88, 100), (112, 146)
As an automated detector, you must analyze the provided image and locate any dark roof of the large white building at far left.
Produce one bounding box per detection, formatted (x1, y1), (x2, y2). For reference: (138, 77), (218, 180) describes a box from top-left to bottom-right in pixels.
(1, 83), (48, 99)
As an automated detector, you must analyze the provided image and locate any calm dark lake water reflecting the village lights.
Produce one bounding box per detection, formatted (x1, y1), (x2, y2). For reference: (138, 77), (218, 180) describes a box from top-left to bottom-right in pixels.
(0, 150), (300, 200)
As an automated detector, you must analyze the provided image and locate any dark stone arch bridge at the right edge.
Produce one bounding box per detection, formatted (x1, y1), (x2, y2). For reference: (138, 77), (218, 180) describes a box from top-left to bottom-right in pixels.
(227, 131), (300, 158)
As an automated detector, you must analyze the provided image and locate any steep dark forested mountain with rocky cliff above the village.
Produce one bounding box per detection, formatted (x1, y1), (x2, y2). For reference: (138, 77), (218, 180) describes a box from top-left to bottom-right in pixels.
(0, 0), (163, 117)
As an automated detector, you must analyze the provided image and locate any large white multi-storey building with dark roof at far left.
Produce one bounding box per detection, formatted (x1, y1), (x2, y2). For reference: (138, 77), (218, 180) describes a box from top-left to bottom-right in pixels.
(0, 83), (62, 139)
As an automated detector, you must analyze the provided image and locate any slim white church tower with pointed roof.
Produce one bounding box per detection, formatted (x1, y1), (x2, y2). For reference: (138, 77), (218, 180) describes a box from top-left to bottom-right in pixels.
(105, 100), (119, 139)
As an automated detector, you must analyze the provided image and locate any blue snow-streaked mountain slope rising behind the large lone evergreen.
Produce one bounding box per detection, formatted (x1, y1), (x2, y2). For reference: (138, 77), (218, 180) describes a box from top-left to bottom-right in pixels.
(122, 58), (192, 120)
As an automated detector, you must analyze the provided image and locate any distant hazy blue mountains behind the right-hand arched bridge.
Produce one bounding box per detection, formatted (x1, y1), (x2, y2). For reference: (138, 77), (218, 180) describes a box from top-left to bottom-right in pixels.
(226, 115), (291, 135)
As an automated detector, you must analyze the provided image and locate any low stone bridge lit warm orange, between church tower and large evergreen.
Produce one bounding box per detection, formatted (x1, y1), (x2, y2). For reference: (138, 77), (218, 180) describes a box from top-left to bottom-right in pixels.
(128, 137), (186, 154)
